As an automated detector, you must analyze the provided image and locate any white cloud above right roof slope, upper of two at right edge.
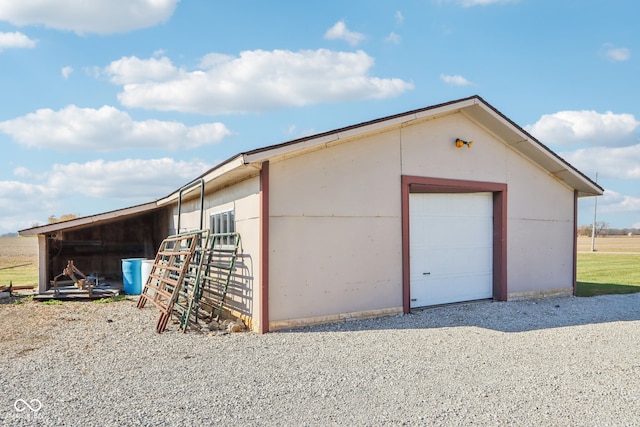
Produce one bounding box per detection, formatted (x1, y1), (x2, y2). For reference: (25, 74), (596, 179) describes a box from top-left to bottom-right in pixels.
(525, 110), (640, 146)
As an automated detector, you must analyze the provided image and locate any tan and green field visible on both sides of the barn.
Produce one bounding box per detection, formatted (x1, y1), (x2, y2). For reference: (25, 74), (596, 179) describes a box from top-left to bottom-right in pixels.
(0, 236), (640, 296)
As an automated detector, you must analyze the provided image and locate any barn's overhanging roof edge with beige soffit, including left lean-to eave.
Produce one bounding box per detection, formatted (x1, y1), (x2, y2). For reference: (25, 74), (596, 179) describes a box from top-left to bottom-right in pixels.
(20, 95), (604, 235)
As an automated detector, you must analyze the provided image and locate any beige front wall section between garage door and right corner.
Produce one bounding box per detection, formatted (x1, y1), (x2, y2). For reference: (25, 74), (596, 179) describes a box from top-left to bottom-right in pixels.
(507, 153), (575, 299)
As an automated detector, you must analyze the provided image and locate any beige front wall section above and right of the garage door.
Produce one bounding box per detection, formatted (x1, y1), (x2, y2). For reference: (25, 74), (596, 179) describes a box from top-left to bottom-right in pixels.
(402, 114), (575, 299)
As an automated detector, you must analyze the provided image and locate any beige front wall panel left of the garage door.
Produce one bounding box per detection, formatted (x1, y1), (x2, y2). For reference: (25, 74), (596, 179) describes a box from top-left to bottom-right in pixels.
(269, 132), (402, 322)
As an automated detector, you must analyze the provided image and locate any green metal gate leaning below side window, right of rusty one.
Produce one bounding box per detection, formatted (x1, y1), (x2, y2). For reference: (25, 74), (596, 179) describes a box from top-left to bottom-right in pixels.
(174, 233), (241, 332)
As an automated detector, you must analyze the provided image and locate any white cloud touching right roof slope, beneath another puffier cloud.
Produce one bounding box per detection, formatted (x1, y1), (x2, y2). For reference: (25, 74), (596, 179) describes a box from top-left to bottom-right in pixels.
(559, 145), (640, 179)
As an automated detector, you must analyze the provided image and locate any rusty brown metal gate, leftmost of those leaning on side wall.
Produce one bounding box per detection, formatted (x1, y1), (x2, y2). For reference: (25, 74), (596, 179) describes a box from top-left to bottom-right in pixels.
(137, 230), (209, 333)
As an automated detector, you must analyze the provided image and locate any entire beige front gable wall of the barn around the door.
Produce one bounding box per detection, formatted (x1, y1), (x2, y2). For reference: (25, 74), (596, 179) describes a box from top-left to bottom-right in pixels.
(269, 113), (574, 324)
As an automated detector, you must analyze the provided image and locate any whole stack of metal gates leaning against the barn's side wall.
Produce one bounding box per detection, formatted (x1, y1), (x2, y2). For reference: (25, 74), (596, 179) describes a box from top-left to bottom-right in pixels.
(138, 230), (240, 333)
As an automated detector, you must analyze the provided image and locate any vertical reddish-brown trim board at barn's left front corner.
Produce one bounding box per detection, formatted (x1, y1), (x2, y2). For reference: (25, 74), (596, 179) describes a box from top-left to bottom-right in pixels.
(259, 161), (269, 334)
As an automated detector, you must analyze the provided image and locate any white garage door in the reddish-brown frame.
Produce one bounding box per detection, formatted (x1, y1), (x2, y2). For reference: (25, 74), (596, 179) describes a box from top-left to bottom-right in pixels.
(409, 193), (493, 308)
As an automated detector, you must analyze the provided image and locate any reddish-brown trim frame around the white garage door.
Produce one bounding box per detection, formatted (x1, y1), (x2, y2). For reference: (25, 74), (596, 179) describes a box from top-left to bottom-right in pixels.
(401, 175), (507, 314)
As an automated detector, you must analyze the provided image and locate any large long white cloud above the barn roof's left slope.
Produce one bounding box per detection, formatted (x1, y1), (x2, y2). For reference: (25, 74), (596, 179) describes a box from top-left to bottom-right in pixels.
(103, 49), (413, 115)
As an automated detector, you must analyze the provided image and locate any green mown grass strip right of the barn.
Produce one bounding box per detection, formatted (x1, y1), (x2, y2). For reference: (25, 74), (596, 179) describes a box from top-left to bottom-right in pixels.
(576, 253), (640, 297)
